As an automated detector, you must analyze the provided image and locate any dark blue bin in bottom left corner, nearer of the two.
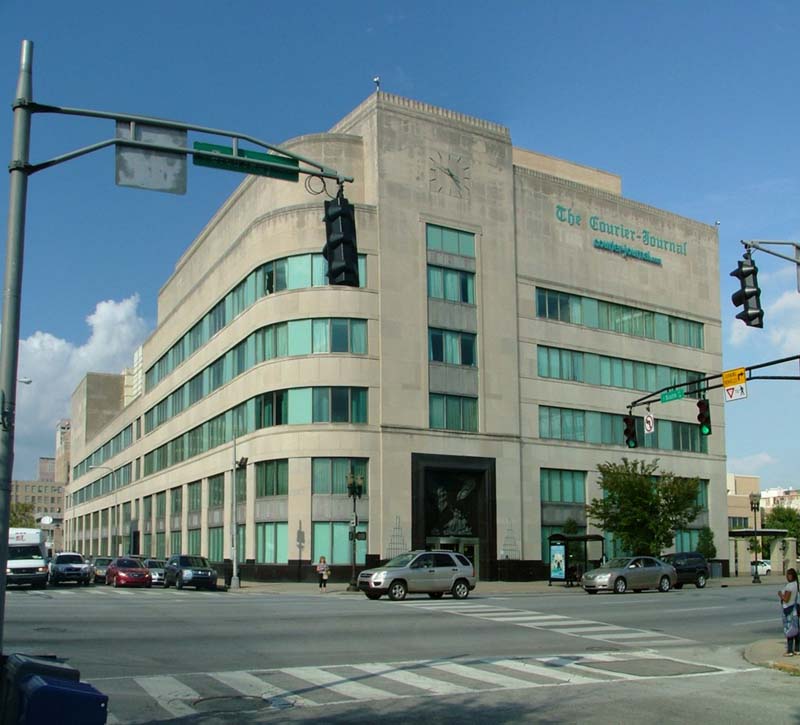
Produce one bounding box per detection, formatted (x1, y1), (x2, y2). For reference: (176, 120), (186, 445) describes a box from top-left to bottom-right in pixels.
(18, 675), (108, 725)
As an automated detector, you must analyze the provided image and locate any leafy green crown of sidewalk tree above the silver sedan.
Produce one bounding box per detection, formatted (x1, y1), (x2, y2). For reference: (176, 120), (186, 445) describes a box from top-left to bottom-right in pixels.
(586, 458), (701, 556)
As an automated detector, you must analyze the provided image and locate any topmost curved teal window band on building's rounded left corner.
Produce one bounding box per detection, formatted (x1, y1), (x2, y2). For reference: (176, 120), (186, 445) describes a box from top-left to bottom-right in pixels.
(145, 254), (367, 392)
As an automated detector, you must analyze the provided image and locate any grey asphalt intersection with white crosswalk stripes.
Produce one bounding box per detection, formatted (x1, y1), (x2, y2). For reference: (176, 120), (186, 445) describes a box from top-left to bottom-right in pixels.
(4, 580), (800, 723)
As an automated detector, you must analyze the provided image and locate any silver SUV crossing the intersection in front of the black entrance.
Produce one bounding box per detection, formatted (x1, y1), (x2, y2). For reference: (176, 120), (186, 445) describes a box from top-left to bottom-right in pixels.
(358, 551), (475, 601)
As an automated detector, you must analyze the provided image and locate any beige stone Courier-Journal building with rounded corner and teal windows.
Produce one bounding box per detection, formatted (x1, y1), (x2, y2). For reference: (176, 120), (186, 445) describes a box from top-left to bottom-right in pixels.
(61, 93), (727, 578)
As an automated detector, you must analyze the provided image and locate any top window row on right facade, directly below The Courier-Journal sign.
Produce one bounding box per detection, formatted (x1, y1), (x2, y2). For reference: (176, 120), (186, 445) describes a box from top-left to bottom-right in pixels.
(536, 287), (704, 350)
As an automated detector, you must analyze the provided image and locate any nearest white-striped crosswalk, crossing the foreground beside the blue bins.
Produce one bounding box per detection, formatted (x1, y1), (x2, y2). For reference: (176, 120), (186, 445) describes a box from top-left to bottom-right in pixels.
(95, 651), (754, 725)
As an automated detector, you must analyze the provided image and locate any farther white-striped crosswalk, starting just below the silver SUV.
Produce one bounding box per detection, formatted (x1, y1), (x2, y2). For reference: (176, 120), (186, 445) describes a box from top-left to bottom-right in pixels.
(392, 600), (695, 647)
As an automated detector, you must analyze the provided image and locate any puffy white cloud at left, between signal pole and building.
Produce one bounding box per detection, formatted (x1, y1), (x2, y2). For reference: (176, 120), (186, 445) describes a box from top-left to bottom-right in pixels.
(14, 295), (147, 479)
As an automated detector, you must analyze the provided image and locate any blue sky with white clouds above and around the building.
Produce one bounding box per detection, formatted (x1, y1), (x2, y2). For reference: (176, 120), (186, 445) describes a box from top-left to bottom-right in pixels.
(0, 0), (800, 488)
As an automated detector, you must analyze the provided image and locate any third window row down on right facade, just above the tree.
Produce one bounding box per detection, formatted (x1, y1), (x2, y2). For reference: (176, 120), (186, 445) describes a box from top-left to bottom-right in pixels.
(539, 405), (708, 453)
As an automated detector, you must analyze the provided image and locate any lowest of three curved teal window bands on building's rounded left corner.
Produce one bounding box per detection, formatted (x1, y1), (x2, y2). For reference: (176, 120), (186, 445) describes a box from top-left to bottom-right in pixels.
(144, 387), (368, 476)
